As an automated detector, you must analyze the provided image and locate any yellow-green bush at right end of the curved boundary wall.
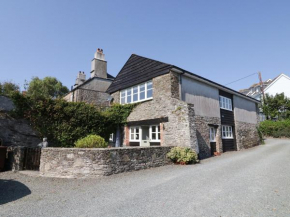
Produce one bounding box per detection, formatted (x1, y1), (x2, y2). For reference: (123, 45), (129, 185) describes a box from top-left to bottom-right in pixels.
(167, 147), (198, 164)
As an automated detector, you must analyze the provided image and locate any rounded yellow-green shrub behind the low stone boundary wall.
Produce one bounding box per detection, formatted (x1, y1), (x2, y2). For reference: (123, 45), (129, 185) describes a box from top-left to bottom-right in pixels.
(75, 135), (108, 148)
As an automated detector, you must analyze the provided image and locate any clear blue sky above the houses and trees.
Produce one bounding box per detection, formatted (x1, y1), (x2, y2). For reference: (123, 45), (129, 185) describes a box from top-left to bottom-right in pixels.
(0, 0), (290, 90)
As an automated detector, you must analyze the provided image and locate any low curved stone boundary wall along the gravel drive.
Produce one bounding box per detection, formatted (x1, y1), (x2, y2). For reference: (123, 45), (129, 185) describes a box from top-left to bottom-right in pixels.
(40, 146), (172, 178)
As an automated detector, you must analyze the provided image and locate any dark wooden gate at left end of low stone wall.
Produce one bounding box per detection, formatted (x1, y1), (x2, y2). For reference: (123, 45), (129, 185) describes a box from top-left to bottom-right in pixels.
(23, 148), (41, 170)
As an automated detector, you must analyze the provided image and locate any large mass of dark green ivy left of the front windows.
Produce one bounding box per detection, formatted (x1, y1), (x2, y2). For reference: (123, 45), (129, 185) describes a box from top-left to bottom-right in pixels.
(11, 93), (136, 147)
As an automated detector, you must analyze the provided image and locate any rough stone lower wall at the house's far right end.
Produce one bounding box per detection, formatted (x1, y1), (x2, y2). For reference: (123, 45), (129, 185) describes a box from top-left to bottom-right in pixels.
(235, 121), (260, 150)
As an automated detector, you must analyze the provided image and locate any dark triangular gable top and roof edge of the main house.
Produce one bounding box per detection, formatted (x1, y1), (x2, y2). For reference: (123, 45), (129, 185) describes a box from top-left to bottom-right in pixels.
(106, 54), (260, 103)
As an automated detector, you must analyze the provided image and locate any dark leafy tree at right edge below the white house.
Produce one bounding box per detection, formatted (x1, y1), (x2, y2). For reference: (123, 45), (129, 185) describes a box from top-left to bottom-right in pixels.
(262, 93), (290, 120)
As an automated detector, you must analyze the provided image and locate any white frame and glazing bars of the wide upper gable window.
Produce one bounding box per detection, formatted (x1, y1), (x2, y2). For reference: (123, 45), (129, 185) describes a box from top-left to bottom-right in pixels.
(120, 80), (154, 104)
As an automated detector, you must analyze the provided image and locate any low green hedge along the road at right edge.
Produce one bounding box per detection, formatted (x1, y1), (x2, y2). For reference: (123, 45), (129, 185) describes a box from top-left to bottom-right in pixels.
(259, 120), (290, 138)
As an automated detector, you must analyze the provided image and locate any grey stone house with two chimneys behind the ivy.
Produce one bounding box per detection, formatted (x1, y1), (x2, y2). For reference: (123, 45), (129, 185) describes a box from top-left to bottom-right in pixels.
(64, 48), (115, 107)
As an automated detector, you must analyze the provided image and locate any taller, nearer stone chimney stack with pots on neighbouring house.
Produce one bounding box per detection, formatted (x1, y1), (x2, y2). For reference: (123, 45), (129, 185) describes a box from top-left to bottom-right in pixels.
(91, 48), (107, 78)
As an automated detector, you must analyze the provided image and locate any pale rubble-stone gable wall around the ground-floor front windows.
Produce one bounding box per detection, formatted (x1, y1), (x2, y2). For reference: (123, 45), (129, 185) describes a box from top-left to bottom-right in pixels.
(125, 72), (197, 150)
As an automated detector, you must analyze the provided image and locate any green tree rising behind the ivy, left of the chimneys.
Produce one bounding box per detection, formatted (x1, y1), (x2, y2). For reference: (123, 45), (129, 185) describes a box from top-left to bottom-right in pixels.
(26, 77), (69, 99)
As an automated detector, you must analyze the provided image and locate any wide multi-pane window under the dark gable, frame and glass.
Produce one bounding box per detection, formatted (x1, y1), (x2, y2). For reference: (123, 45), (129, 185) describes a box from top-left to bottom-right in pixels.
(120, 81), (153, 104)
